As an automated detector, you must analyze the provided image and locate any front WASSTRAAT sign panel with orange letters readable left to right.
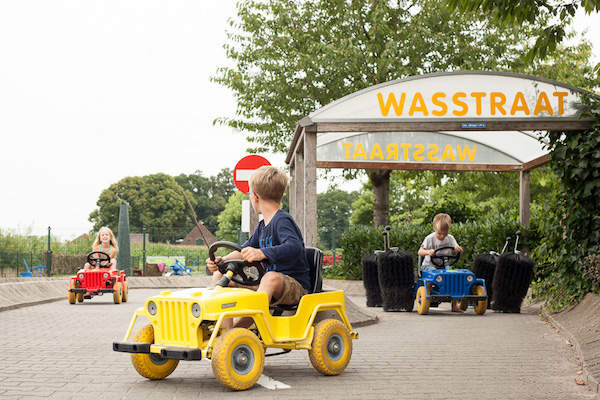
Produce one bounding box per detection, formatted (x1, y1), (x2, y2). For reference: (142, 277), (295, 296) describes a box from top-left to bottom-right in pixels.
(310, 72), (580, 123)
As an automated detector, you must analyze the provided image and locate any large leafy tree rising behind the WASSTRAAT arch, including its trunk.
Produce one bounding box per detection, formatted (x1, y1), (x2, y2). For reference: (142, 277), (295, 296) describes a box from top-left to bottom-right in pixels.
(212, 0), (596, 225)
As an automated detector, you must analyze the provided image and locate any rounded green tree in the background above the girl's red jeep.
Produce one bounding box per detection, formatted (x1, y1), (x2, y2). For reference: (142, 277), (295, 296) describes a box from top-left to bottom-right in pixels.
(89, 173), (191, 241)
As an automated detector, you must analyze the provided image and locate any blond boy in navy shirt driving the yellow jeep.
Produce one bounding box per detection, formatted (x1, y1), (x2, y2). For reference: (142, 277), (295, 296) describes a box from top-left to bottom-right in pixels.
(206, 166), (310, 326)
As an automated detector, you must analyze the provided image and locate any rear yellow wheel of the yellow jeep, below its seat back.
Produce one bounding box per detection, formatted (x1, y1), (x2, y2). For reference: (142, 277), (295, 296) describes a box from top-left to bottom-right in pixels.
(308, 319), (352, 375)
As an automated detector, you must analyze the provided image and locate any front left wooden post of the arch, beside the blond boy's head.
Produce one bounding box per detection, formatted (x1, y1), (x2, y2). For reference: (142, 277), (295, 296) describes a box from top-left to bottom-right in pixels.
(304, 130), (319, 247)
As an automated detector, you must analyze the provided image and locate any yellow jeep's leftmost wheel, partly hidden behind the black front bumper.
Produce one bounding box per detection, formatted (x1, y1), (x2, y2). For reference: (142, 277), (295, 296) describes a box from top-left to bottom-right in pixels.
(131, 324), (179, 379)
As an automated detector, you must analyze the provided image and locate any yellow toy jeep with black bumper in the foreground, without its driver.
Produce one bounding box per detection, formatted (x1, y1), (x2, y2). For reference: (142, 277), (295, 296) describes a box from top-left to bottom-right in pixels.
(113, 242), (358, 390)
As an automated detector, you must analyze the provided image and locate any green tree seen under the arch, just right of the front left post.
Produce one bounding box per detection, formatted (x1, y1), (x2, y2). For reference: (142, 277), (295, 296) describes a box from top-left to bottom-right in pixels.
(317, 187), (356, 249)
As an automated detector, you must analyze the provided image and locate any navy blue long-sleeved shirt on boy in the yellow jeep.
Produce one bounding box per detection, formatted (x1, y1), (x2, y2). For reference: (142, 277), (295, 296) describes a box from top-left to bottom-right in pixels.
(242, 210), (310, 291)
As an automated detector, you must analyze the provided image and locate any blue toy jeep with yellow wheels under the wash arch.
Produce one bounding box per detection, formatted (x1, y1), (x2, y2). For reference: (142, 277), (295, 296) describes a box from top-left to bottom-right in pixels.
(415, 247), (488, 315)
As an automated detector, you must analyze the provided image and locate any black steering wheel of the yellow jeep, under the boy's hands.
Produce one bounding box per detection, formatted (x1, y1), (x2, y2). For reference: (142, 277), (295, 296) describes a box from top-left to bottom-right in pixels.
(208, 241), (265, 287)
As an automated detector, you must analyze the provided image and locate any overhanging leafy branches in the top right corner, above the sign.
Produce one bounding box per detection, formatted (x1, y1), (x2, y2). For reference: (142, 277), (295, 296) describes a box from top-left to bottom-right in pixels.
(450, 0), (600, 65)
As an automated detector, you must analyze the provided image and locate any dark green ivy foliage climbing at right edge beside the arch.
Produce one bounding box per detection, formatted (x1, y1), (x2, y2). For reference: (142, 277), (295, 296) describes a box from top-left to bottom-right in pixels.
(535, 98), (600, 310)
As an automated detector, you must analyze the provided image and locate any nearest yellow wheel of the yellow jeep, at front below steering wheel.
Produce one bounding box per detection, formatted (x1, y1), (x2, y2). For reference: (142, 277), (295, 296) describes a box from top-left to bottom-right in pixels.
(211, 328), (265, 390)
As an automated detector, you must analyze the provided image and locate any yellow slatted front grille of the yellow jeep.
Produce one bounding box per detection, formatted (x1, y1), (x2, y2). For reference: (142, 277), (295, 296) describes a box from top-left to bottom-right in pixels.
(155, 300), (191, 346)
